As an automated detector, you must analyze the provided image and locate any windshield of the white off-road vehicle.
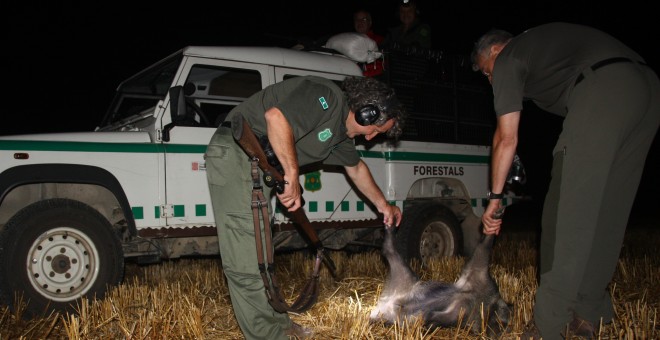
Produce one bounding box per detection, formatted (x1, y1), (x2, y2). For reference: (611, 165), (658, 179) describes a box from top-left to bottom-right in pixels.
(100, 51), (183, 127)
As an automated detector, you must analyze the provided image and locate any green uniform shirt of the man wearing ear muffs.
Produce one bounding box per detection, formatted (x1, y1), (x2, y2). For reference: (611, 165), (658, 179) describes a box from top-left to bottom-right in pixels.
(226, 76), (360, 166)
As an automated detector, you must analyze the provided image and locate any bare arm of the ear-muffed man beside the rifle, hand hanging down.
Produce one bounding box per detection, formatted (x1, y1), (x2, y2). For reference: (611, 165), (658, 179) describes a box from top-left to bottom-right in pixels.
(264, 107), (302, 211)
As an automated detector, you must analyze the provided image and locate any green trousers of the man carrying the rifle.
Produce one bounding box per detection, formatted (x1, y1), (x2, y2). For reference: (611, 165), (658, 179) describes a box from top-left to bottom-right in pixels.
(206, 127), (292, 339)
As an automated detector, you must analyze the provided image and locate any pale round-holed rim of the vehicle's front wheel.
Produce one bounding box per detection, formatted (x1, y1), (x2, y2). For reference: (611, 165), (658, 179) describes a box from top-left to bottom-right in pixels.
(27, 227), (99, 301)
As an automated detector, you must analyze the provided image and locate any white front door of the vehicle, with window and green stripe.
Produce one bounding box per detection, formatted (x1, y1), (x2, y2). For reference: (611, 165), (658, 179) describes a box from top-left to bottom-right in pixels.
(161, 57), (273, 228)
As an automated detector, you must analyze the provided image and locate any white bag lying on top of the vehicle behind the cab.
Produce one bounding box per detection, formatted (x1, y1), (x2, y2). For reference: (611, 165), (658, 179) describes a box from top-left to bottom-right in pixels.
(323, 32), (383, 63)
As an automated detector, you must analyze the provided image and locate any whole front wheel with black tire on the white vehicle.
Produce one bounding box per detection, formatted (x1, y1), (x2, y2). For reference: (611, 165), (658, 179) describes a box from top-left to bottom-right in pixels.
(0, 198), (124, 317)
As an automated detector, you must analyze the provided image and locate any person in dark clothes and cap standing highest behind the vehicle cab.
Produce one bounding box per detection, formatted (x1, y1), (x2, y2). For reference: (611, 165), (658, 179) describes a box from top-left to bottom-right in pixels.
(383, 0), (431, 49)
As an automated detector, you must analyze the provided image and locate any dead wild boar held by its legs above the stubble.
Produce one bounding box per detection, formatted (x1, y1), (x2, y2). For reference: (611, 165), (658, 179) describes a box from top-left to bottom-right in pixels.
(370, 228), (511, 335)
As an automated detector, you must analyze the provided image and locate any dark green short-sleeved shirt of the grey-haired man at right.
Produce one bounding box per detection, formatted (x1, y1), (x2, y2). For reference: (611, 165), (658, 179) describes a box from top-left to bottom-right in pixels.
(492, 23), (643, 117)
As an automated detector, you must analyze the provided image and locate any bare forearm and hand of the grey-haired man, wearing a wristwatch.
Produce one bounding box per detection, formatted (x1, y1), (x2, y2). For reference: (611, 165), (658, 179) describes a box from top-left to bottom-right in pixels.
(481, 111), (520, 235)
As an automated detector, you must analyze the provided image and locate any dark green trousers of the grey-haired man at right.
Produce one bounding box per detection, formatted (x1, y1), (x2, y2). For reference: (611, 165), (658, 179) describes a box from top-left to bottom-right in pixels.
(534, 63), (660, 340)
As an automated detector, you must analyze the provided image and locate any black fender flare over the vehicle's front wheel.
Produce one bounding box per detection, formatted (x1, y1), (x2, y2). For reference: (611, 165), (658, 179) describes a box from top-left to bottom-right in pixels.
(0, 164), (137, 236)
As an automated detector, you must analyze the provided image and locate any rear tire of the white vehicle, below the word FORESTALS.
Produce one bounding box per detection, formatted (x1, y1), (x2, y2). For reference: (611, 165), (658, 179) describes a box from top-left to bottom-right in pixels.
(395, 204), (463, 263)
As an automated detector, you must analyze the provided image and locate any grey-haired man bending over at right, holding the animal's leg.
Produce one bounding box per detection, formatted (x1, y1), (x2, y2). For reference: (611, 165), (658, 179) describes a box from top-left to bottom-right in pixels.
(472, 23), (660, 340)
